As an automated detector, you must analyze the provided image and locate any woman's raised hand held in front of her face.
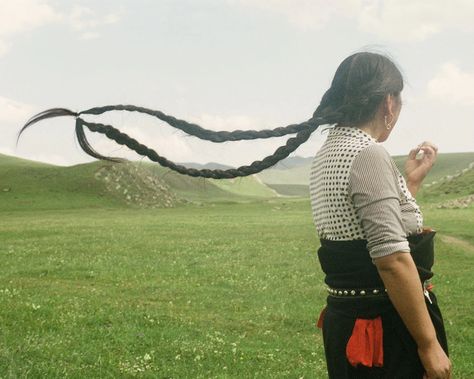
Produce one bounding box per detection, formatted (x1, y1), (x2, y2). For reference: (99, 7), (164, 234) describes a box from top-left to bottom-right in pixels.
(405, 141), (438, 193)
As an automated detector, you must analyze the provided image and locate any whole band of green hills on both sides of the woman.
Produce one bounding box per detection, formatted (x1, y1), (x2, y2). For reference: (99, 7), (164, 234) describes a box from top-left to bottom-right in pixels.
(0, 153), (474, 211)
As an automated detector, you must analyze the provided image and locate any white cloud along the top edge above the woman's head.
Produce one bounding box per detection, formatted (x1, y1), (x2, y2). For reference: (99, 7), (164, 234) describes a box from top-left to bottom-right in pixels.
(228, 0), (474, 42)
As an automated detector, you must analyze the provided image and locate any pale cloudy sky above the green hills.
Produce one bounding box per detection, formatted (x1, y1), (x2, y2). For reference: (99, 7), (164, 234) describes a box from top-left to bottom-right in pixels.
(0, 0), (474, 165)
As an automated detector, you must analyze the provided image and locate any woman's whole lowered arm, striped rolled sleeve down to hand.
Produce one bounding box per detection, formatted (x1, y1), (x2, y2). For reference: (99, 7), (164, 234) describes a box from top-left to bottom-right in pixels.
(348, 145), (450, 379)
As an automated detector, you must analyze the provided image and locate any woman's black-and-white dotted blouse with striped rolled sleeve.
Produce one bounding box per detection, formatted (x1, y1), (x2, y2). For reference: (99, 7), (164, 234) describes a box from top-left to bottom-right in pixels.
(310, 126), (423, 258)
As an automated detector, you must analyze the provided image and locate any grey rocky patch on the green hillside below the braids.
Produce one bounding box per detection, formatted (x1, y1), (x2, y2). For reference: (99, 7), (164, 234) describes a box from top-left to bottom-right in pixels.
(95, 162), (182, 208)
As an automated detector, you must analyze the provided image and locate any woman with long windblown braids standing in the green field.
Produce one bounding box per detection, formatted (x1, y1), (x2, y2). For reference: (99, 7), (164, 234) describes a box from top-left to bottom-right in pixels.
(20, 52), (451, 379)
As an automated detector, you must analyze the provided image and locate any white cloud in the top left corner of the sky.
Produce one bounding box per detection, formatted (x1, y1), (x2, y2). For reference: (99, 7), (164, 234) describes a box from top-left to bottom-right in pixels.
(0, 0), (124, 56)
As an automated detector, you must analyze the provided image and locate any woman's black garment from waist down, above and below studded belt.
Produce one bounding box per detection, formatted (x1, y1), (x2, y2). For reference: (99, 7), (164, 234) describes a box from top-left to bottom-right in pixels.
(318, 231), (448, 379)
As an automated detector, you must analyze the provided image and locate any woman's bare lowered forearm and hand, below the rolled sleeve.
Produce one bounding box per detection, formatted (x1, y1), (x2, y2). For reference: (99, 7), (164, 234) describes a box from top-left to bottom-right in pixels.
(374, 252), (451, 378)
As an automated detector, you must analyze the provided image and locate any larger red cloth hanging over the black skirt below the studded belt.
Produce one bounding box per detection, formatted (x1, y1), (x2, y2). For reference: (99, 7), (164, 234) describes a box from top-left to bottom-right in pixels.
(346, 316), (383, 367)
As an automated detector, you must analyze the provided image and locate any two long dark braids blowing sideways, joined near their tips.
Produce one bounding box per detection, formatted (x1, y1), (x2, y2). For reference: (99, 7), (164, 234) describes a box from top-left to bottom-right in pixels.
(17, 105), (334, 179)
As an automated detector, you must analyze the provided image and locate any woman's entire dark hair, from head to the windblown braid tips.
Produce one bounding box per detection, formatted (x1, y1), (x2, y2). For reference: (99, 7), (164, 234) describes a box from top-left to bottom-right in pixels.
(17, 52), (403, 179)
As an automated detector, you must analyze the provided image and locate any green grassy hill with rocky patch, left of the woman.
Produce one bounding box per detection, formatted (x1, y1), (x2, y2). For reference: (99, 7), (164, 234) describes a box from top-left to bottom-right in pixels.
(0, 154), (277, 211)
